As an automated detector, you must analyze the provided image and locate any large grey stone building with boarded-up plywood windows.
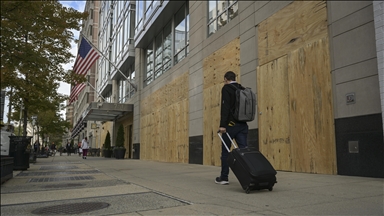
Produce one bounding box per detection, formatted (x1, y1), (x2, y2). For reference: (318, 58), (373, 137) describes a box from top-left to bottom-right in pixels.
(74, 0), (384, 177)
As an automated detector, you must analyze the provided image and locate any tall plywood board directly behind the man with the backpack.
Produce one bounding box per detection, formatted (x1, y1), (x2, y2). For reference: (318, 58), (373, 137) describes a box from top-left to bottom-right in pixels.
(203, 38), (240, 166)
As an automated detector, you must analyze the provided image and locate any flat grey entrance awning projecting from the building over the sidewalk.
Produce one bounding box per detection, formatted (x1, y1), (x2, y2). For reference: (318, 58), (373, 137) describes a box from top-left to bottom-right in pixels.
(83, 102), (133, 121)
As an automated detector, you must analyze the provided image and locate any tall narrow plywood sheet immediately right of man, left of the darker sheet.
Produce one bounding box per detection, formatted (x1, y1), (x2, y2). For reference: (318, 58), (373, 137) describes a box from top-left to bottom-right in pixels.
(257, 56), (292, 171)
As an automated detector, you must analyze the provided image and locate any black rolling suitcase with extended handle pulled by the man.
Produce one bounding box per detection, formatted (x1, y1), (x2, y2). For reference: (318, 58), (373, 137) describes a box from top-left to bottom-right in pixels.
(218, 133), (277, 194)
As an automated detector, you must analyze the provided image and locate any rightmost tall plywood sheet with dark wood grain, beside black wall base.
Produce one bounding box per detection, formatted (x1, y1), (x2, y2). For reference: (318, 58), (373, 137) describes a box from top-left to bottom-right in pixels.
(288, 37), (336, 174)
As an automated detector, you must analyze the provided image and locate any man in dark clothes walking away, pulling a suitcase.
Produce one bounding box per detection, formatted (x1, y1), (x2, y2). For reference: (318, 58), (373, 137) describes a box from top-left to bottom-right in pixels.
(215, 71), (248, 185)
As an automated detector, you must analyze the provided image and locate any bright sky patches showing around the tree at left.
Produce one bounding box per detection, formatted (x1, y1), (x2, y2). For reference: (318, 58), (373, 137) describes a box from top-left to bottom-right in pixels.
(3, 0), (86, 122)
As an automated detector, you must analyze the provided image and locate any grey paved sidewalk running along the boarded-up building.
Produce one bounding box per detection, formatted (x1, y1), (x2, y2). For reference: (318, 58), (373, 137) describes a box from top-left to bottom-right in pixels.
(1, 154), (384, 215)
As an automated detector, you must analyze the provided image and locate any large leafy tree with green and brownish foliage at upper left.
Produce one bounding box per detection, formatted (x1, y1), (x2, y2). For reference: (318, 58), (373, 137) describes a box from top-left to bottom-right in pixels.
(0, 0), (88, 136)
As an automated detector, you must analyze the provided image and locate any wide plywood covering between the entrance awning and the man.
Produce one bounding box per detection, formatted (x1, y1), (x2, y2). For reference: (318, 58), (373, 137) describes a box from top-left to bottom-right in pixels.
(140, 72), (189, 163)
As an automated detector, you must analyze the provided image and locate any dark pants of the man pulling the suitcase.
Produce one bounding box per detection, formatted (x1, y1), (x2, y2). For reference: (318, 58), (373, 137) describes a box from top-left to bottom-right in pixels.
(220, 123), (248, 180)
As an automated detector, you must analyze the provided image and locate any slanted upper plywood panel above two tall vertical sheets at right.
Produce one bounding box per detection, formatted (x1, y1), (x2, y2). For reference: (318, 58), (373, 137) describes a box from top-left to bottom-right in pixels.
(258, 1), (328, 65)
